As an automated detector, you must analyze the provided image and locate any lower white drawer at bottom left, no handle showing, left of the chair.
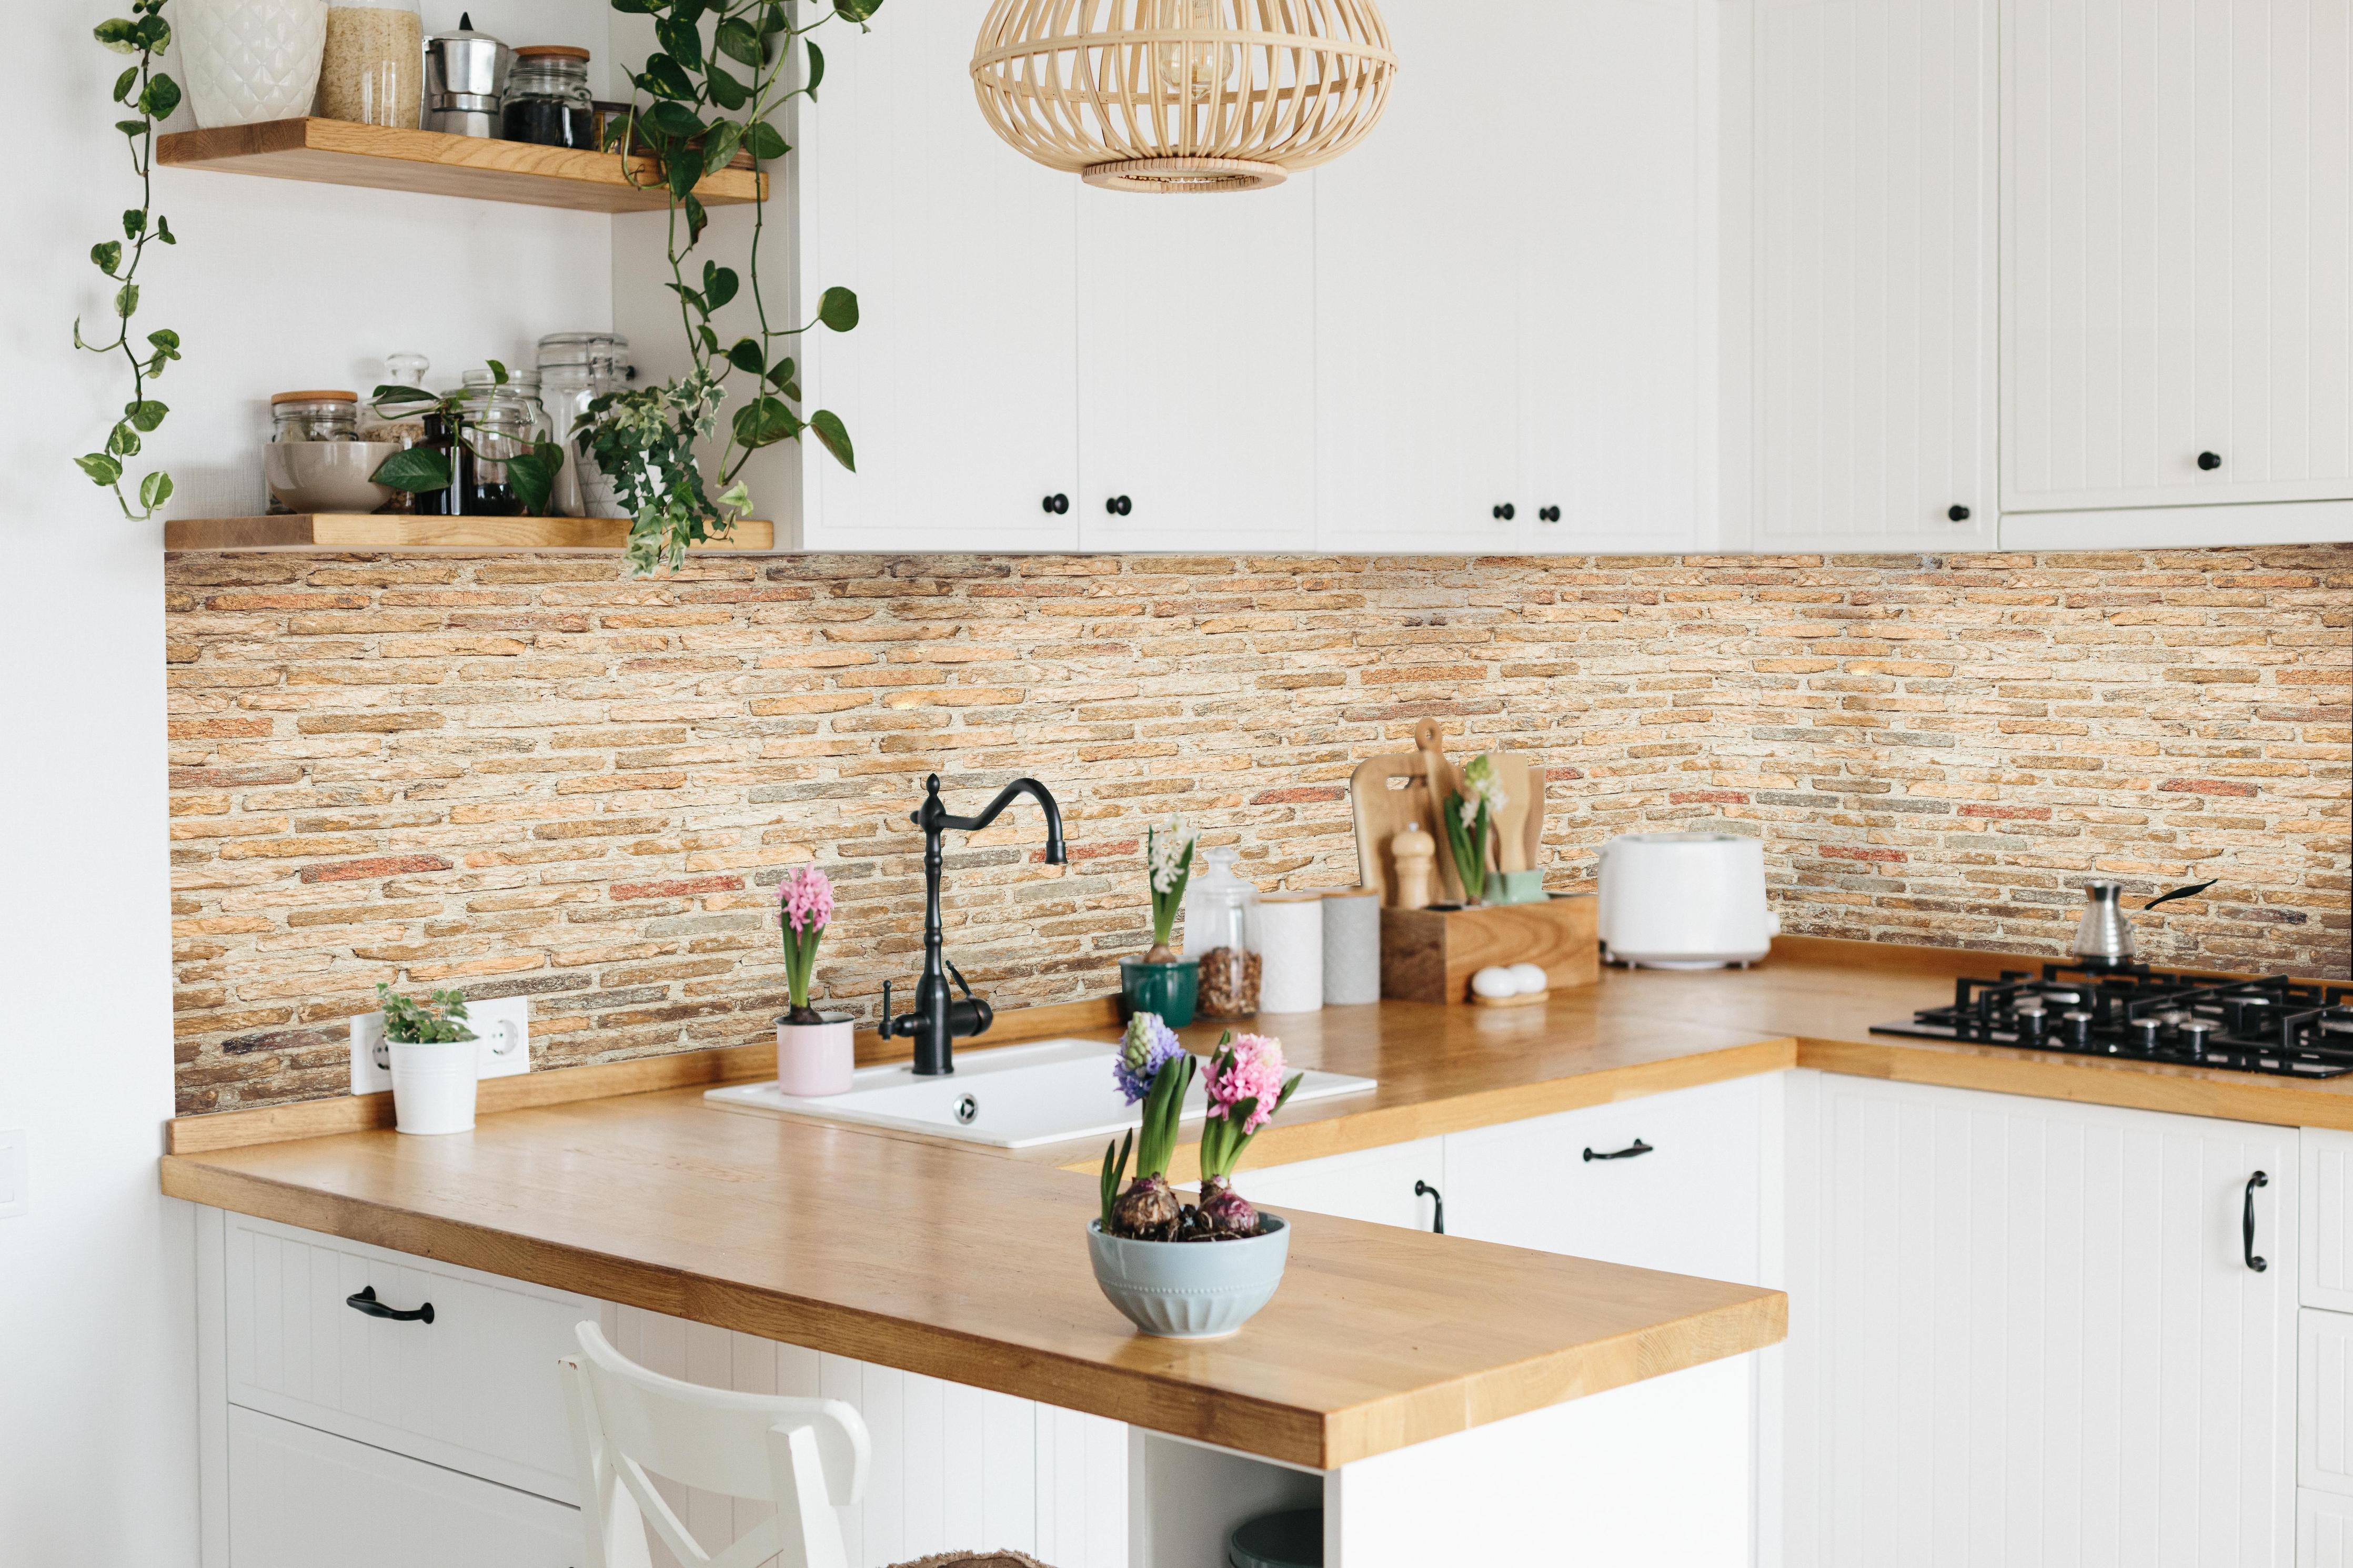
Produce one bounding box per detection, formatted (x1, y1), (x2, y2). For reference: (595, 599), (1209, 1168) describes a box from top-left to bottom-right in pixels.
(228, 1408), (586, 1568)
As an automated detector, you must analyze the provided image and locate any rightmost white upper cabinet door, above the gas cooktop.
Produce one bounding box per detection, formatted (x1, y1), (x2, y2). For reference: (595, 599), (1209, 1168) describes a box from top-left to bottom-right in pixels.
(2003, 0), (2353, 522)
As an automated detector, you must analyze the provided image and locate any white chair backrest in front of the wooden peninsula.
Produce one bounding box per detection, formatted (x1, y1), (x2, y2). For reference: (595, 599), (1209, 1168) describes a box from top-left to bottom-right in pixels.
(560, 1323), (871, 1568)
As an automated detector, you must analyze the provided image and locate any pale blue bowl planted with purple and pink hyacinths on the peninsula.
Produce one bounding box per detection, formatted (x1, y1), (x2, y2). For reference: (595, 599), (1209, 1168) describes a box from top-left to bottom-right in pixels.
(1087, 1013), (1303, 1340)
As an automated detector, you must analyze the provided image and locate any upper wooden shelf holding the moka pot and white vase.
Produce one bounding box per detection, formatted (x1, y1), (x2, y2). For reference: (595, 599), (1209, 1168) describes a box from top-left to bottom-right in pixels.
(155, 120), (767, 211)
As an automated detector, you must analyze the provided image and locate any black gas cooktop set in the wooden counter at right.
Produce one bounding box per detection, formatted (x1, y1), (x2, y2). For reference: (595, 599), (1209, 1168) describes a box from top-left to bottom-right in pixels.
(1871, 964), (2353, 1079)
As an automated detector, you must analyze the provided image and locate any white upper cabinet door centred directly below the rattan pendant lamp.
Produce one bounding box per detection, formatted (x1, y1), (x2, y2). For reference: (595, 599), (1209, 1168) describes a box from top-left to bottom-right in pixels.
(1082, 179), (1315, 550)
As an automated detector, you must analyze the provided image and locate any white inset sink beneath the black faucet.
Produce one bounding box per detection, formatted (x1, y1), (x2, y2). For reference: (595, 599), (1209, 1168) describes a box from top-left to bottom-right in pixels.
(703, 1039), (1376, 1149)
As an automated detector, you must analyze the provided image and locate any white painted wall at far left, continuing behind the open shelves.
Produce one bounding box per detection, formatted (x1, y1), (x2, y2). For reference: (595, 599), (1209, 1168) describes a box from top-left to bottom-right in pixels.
(0, 0), (612, 1568)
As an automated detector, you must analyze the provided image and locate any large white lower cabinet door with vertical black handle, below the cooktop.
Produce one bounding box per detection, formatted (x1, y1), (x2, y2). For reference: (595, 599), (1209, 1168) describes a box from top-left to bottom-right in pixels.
(1784, 1072), (2297, 1568)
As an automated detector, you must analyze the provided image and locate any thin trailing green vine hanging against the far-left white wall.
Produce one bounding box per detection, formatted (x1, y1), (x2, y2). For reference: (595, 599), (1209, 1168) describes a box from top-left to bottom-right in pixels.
(73, 0), (179, 522)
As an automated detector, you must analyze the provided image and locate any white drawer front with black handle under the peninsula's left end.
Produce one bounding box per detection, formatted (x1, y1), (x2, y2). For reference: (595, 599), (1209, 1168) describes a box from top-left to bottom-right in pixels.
(224, 1216), (602, 1502)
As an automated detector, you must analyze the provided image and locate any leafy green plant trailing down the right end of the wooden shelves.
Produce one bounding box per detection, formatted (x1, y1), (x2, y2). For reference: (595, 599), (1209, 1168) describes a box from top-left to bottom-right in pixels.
(592, 0), (882, 571)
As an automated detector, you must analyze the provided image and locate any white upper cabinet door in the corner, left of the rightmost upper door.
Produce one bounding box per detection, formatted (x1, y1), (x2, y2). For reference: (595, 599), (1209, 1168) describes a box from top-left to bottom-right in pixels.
(1734, 0), (1998, 550)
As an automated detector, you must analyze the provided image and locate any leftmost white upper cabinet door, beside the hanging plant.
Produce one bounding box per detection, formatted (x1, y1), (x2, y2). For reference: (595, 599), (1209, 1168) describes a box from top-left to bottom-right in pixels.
(793, 7), (1080, 550)
